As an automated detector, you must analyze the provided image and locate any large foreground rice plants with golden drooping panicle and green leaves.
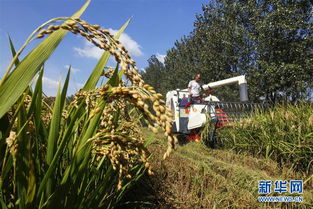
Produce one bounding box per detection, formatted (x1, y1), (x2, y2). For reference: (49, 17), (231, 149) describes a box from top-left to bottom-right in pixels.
(0, 1), (174, 209)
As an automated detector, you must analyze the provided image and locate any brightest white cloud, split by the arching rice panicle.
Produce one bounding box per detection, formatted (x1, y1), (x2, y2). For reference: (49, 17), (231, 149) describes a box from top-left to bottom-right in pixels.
(74, 28), (143, 59)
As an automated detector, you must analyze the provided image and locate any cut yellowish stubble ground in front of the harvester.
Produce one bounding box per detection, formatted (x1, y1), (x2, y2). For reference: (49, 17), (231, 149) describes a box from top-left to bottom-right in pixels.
(145, 131), (313, 209)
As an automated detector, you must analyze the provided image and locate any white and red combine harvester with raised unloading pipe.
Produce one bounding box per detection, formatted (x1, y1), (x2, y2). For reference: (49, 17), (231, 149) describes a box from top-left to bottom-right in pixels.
(166, 75), (266, 147)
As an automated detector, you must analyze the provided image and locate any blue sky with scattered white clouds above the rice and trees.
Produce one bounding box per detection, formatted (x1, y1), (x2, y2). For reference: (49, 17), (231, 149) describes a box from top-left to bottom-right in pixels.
(0, 0), (208, 95)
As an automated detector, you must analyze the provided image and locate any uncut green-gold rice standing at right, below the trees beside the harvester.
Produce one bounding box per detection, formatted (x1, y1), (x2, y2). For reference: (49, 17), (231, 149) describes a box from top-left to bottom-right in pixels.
(219, 103), (313, 174)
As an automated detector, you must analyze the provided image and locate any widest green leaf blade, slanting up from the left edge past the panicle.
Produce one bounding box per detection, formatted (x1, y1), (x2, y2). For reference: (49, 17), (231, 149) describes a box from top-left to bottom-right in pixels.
(0, 0), (90, 118)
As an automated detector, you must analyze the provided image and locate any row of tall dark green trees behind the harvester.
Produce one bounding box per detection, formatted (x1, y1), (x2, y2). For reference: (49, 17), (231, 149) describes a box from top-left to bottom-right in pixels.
(142, 0), (313, 102)
